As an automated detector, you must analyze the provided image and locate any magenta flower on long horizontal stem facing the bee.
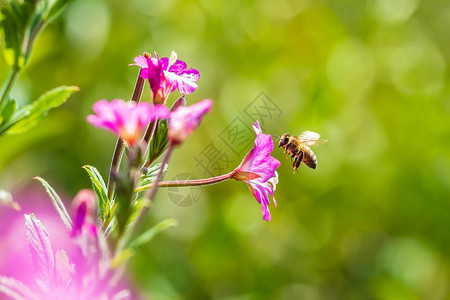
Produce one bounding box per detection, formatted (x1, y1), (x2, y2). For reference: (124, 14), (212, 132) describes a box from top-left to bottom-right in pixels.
(232, 121), (280, 221)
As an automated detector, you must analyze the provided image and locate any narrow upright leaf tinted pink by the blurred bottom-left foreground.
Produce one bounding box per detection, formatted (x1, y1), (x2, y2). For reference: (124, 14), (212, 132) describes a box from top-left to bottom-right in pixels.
(25, 214), (55, 289)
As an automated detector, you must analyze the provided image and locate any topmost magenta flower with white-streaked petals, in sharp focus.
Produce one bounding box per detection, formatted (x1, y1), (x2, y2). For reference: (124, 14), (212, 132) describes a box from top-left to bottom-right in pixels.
(133, 51), (200, 104)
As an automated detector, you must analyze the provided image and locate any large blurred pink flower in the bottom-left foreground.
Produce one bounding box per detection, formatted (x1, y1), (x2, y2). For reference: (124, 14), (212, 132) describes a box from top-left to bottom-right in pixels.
(0, 214), (130, 300)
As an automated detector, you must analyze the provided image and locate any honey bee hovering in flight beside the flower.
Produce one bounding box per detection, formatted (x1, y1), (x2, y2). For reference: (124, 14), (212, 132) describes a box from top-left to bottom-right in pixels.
(278, 131), (327, 172)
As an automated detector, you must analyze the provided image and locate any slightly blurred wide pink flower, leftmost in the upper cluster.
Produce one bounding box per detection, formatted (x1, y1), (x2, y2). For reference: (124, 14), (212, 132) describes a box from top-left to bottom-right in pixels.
(87, 99), (170, 146)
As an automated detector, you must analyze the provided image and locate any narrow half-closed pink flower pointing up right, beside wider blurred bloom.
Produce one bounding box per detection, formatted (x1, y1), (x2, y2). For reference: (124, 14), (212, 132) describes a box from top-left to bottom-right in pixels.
(168, 99), (212, 145)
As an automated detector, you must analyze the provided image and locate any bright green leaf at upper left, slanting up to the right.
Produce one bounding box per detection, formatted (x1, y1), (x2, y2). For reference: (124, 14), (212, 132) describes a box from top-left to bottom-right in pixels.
(7, 86), (79, 134)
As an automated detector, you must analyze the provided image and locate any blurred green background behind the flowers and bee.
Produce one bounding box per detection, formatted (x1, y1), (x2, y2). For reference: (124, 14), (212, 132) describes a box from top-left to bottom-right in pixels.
(0, 0), (450, 300)
